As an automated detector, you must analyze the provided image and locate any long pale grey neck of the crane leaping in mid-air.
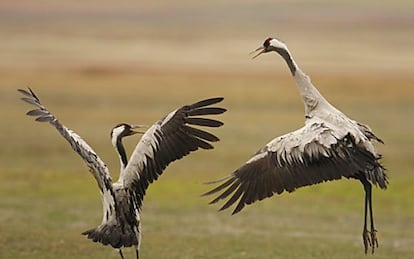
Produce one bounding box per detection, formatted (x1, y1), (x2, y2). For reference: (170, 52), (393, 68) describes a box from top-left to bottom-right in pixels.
(276, 49), (330, 116)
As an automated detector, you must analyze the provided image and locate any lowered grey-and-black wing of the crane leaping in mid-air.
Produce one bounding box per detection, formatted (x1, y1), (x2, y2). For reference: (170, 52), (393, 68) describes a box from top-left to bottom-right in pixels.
(204, 119), (387, 214)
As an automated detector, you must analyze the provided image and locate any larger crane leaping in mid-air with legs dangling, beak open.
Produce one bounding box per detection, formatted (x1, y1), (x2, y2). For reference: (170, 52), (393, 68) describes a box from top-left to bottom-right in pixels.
(203, 38), (388, 254)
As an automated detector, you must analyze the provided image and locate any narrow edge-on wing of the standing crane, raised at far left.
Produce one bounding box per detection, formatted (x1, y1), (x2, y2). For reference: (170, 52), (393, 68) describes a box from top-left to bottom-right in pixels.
(18, 88), (115, 218)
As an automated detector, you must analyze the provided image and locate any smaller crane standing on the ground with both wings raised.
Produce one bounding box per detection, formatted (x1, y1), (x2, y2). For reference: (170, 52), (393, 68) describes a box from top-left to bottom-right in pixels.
(18, 88), (226, 259)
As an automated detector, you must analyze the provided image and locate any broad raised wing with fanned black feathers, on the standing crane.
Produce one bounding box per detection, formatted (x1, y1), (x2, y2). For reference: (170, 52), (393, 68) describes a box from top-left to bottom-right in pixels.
(118, 97), (226, 208)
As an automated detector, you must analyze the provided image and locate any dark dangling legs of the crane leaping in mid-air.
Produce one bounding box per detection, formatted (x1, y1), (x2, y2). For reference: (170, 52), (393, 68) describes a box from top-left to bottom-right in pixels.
(359, 176), (378, 254)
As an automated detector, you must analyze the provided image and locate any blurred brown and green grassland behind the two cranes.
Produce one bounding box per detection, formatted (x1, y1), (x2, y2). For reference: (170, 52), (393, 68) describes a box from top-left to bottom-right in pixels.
(0, 0), (414, 258)
